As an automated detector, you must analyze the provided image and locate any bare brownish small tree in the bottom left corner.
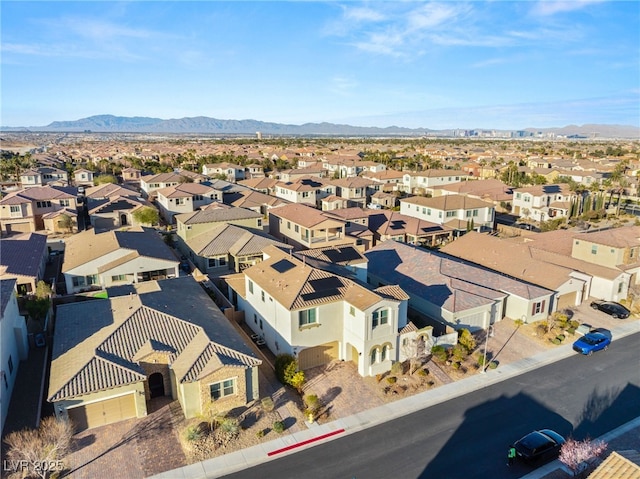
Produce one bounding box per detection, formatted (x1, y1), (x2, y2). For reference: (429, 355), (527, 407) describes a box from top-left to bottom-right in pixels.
(4, 416), (73, 479)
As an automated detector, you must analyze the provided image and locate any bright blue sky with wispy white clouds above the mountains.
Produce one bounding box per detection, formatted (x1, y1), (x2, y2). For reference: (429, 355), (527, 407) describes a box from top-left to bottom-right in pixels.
(0, 0), (640, 129)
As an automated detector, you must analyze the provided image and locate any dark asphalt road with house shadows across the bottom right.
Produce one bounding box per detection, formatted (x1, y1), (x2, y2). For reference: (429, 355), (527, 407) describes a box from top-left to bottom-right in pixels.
(225, 334), (640, 479)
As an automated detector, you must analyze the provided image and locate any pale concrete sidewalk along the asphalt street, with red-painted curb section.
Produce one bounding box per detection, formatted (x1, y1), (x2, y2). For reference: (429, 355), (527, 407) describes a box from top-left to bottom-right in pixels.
(153, 321), (640, 479)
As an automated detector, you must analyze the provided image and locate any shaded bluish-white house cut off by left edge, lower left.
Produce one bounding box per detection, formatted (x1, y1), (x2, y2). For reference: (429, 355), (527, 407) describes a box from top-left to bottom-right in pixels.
(0, 278), (29, 432)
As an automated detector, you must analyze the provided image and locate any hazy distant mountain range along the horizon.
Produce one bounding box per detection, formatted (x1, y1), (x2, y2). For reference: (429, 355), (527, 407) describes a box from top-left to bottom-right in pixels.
(0, 115), (640, 139)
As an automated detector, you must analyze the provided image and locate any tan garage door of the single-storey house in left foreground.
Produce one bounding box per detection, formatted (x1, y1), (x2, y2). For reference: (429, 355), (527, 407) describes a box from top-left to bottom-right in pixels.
(67, 394), (136, 431)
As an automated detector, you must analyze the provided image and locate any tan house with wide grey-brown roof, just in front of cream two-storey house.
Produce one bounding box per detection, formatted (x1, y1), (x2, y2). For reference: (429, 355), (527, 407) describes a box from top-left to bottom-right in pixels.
(175, 203), (262, 242)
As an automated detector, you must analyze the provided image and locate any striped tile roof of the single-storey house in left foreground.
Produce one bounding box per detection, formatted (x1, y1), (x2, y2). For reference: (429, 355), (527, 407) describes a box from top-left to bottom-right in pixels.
(48, 277), (260, 401)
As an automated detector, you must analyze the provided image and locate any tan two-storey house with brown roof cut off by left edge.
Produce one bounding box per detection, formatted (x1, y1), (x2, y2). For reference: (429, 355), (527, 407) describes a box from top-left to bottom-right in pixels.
(0, 186), (77, 234)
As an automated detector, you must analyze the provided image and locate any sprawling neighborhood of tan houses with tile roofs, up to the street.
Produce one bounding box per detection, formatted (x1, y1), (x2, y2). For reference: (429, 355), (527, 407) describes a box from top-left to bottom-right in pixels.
(0, 135), (640, 477)
